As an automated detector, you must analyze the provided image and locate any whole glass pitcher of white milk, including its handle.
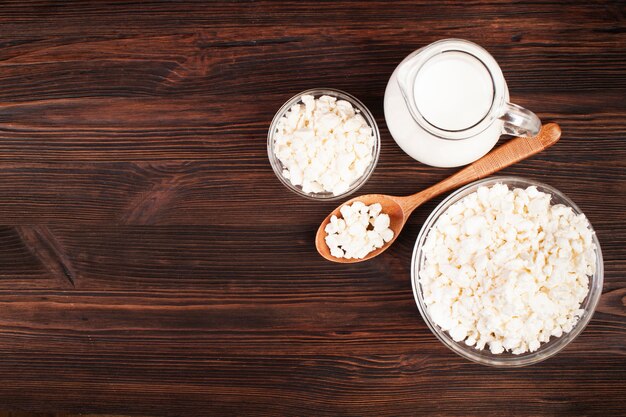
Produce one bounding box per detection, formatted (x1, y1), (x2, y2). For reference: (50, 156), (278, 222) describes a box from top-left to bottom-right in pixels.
(385, 39), (541, 167)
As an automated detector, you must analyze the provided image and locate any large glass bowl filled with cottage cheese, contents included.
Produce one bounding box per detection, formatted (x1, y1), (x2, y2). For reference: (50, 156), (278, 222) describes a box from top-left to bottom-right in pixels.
(412, 177), (603, 366)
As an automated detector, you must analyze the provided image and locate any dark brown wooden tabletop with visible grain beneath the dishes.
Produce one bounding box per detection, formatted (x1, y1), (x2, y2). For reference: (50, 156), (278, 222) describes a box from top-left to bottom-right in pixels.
(0, 0), (626, 416)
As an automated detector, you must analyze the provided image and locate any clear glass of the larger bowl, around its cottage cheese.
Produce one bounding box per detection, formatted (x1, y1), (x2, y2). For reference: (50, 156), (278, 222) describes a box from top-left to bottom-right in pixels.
(411, 177), (604, 367)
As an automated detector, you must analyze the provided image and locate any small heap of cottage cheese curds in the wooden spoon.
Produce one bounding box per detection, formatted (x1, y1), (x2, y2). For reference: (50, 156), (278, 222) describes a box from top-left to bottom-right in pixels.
(324, 201), (393, 259)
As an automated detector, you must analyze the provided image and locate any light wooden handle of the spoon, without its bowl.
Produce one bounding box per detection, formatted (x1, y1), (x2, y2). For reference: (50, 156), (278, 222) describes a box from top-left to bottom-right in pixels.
(403, 123), (561, 212)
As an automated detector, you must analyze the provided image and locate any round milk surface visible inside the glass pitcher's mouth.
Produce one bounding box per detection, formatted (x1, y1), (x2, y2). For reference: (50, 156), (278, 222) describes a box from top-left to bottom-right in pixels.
(413, 51), (493, 130)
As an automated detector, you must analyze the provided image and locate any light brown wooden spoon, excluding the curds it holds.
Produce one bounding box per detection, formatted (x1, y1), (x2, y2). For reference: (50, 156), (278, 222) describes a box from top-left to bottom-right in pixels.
(315, 123), (561, 263)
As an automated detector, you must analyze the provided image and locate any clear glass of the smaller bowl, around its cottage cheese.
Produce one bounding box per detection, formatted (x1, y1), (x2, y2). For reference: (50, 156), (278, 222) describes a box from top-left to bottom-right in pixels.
(267, 88), (380, 201)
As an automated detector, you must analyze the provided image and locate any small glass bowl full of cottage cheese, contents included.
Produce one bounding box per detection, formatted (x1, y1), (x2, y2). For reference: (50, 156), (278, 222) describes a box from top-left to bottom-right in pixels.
(267, 90), (380, 200)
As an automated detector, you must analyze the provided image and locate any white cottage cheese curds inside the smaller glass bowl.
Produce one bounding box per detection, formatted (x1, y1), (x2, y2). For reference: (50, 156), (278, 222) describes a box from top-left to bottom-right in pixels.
(274, 95), (375, 195)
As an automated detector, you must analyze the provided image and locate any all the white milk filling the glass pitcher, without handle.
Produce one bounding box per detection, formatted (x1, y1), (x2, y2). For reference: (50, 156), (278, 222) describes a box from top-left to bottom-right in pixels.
(385, 44), (509, 167)
